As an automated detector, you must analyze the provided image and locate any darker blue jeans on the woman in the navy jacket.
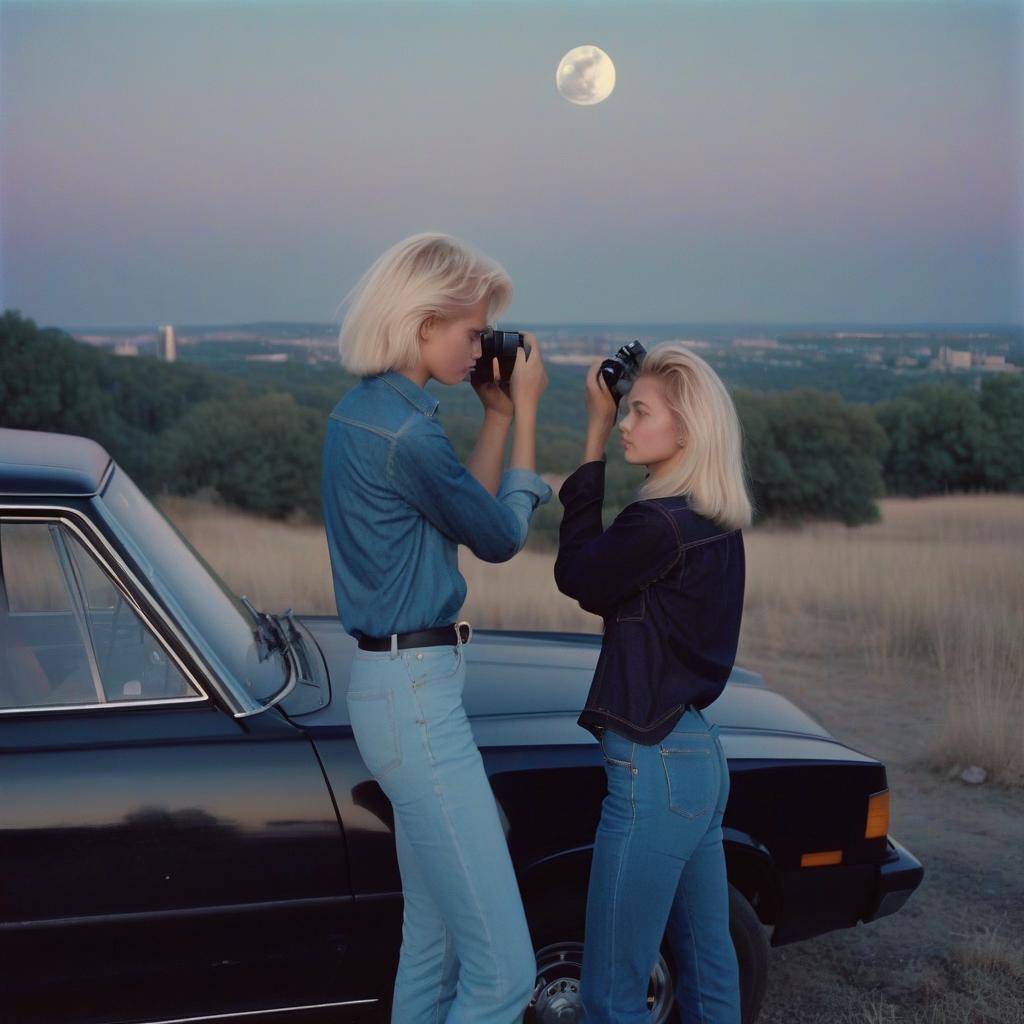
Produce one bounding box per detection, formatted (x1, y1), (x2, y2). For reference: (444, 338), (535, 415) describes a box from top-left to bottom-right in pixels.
(581, 709), (739, 1024)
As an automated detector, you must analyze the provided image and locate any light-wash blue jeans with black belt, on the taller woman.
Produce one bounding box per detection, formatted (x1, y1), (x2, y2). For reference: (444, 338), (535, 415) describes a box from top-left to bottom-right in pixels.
(347, 642), (536, 1024)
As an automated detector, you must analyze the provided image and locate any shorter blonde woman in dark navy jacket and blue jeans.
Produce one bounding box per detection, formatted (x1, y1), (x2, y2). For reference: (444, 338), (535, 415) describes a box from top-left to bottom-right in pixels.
(555, 344), (751, 1024)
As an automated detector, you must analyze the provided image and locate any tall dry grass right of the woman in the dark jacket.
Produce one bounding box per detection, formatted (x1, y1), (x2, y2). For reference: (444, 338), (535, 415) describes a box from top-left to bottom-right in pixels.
(744, 496), (1024, 785)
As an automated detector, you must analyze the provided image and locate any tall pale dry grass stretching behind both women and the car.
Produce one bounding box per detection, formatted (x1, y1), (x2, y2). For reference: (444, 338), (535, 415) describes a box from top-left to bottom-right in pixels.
(161, 496), (1024, 785)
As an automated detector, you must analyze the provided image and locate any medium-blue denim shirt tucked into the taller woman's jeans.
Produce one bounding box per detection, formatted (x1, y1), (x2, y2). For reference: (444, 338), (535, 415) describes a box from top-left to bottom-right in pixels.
(322, 370), (552, 638)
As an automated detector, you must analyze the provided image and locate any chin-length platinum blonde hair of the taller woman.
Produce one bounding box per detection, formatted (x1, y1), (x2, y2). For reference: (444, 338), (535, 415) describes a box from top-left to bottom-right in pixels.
(338, 232), (512, 377)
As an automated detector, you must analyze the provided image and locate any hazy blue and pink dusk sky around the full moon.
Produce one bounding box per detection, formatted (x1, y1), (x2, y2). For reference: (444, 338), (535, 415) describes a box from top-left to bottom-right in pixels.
(0, 0), (1024, 328)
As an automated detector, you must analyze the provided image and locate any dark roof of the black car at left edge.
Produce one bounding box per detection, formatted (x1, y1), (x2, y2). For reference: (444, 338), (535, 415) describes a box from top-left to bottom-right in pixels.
(0, 427), (111, 497)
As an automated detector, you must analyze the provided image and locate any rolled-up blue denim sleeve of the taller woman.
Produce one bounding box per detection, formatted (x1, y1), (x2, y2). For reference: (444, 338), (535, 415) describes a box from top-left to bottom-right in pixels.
(388, 420), (552, 562)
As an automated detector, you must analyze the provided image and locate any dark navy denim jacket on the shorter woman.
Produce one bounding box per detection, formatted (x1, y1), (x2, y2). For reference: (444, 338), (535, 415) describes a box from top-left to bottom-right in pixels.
(555, 460), (744, 744)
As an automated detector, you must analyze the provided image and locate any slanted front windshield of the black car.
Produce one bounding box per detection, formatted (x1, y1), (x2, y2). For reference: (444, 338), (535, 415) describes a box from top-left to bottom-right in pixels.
(96, 466), (289, 712)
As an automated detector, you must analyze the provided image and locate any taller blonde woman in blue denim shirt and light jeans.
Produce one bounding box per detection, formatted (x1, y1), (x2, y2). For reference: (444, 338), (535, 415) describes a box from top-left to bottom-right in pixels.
(323, 233), (551, 1024)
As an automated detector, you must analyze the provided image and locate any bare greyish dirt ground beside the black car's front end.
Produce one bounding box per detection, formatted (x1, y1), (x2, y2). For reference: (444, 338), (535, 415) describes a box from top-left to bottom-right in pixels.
(740, 631), (1024, 1024)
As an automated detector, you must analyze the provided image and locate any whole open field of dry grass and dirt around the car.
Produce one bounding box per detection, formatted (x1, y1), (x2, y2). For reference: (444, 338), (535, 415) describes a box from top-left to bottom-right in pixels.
(161, 496), (1024, 1024)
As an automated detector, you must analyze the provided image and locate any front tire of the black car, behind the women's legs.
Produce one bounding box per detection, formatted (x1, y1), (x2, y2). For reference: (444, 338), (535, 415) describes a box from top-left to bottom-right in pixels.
(525, 885), (768, 1024)
